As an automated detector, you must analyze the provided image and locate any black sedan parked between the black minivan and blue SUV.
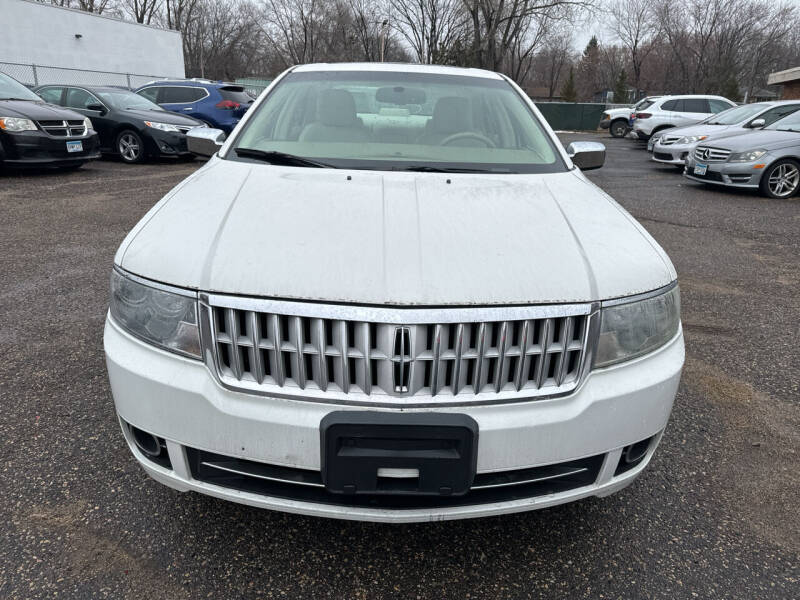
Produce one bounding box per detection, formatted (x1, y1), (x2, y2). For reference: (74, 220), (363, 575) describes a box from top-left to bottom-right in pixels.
(36, 85), (203, 163)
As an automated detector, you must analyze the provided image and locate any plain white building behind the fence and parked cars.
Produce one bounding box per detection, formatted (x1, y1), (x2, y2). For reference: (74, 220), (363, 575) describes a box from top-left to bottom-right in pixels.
(0, 0), (185, 85)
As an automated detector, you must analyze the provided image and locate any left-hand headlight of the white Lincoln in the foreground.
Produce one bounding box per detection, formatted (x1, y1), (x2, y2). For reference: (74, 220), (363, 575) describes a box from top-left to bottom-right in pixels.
(111, 269), (202, 358)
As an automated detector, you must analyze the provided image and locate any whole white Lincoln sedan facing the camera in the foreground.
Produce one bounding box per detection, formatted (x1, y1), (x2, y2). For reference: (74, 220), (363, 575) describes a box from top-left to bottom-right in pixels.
(104, 63), (684, 522)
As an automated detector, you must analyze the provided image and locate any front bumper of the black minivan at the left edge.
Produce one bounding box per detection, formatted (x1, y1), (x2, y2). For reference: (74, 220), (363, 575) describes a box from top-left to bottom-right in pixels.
(0, 130), (100, 167)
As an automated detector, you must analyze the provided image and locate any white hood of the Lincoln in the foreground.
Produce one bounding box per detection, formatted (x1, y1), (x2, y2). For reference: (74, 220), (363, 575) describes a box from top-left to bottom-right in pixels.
(116, 159), (676, 306)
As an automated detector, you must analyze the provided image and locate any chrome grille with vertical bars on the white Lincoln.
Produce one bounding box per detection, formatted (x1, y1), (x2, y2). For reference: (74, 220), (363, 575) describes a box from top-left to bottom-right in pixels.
(202, 296), (592, 403)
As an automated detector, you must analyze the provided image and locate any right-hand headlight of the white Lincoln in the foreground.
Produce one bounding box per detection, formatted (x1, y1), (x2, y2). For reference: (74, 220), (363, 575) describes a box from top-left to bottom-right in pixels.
(594, 285), (681, 367)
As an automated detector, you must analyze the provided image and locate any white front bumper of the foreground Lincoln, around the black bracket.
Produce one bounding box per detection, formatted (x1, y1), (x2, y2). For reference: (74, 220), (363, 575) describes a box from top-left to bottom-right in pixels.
(104, 318), (684, 522)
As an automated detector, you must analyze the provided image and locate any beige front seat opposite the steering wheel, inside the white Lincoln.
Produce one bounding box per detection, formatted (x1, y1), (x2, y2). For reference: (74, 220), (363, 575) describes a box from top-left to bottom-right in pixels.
(298, 90), (369, 142)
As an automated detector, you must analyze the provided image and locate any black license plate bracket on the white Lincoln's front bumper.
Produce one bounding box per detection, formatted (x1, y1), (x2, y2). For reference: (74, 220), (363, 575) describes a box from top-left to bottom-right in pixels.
(320, 411), (478, 496)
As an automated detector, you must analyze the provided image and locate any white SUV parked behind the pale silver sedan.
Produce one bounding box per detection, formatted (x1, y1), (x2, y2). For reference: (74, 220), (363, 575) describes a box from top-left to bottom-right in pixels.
(633, 96), (736, 140)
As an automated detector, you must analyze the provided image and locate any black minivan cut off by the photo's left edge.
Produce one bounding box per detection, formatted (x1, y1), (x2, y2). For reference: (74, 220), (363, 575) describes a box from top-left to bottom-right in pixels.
(0, 73), (100, 169)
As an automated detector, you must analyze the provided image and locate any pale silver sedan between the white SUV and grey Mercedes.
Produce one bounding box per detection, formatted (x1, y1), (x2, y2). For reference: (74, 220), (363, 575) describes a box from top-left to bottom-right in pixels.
(647, 100), (800, 166)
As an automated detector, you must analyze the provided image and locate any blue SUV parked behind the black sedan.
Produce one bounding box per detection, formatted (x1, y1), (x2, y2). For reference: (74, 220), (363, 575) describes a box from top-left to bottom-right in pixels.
(136, 79), (253, 133)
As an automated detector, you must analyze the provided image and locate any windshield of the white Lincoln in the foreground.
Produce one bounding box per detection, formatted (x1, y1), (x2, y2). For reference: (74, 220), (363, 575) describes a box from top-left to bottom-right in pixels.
(227, 71), (566, 173)
